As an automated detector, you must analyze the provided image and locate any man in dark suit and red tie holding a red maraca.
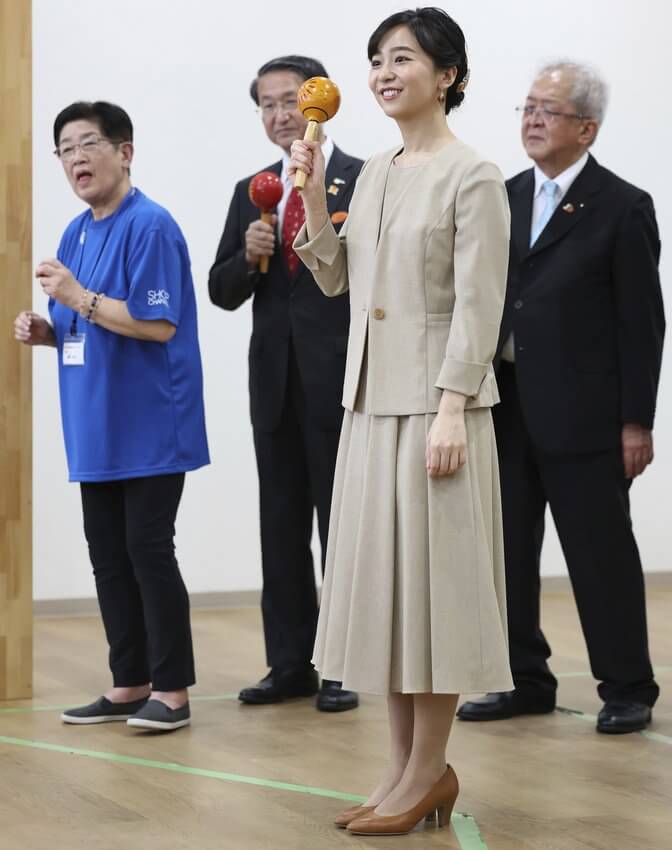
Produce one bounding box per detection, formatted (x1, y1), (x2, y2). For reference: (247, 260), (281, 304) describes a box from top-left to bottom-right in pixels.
(208, 56), (362, 711)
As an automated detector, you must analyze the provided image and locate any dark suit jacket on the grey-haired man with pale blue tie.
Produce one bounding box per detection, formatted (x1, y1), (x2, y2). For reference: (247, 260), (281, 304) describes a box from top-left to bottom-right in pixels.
(498, 156), (665, 452)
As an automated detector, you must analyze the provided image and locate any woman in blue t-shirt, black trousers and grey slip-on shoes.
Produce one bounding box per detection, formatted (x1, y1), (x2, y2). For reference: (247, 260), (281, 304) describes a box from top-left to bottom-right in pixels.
(15, 102), (209, 730)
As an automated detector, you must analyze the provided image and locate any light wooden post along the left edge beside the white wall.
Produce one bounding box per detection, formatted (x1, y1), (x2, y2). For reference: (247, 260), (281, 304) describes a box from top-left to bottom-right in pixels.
(0, 0), (33, 701)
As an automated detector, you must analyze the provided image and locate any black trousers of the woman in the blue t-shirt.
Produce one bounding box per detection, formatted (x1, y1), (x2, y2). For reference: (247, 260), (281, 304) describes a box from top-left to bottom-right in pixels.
(81, 473), (195, 691)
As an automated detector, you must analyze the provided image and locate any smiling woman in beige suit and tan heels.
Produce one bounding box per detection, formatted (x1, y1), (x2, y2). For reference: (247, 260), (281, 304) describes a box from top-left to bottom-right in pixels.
(292, 8), (512, 834)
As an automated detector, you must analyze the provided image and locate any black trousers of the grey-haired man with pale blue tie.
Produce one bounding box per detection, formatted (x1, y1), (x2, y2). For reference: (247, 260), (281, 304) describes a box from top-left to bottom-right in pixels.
(493, 363), (658, 706)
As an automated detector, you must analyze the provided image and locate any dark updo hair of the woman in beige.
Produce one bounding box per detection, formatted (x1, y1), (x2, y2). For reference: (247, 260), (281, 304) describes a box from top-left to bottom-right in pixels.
(367, 6), (469, 115)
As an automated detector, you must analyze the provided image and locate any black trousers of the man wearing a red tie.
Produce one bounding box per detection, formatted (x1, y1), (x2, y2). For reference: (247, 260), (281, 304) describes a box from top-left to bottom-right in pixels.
(254, 346), (340, 672)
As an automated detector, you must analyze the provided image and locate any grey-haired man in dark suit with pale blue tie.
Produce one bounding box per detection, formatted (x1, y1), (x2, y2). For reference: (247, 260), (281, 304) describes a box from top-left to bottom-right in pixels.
(458, 63), (665, 733)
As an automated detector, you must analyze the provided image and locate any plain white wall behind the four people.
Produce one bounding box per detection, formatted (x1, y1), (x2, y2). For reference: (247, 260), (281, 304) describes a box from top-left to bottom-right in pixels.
(33, 0), (672, 599)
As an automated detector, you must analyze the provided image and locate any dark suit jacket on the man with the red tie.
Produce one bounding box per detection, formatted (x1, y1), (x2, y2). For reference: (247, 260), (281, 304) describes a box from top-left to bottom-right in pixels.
(208, 147), (363, 431)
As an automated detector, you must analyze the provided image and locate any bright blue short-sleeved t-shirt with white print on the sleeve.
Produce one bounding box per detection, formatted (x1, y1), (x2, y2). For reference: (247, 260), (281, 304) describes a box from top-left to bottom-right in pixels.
(49, 189), (210, 481)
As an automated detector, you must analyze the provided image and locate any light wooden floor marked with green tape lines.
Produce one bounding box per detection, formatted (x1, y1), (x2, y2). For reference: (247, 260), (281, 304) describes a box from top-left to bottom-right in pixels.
(0, 590), (672, 850)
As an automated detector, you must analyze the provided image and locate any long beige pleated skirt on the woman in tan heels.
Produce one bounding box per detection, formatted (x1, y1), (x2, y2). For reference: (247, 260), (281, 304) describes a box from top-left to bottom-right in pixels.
(313, 368), (513, 694)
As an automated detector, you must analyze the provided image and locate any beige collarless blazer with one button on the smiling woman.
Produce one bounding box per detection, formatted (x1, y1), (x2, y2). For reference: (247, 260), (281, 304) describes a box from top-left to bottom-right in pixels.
(294, 141), (509, 416)
